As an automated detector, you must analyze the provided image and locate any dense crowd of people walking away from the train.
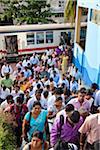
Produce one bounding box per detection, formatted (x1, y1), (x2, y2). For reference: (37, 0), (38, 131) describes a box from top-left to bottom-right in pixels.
(0, 48), (100, 150)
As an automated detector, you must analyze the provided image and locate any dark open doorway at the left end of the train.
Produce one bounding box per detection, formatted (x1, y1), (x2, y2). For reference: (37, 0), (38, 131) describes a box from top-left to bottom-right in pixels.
(5, 35), (18, 56)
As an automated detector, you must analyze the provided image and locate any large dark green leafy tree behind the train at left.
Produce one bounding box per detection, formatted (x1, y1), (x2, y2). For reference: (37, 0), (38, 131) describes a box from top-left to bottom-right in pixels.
(0, 0), (53, 24)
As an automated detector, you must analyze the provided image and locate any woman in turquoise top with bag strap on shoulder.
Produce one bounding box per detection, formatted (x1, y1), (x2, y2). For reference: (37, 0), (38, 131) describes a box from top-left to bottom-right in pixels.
(22, 101), (48, 142)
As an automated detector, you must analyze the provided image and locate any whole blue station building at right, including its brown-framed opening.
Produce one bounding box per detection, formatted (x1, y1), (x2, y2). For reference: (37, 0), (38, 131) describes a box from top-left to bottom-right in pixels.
(74, 0), (100, 87)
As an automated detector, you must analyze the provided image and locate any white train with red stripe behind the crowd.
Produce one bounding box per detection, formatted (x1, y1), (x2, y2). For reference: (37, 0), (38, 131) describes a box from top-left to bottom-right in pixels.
(0, 23), (87, 57)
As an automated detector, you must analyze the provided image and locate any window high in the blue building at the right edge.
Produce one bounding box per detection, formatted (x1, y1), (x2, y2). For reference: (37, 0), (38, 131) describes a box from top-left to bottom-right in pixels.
(90, 9), (100, 25)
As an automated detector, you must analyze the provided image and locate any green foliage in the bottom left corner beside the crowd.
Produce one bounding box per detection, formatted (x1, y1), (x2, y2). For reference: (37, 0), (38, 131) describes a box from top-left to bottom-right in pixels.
(0, 112), (16, 150)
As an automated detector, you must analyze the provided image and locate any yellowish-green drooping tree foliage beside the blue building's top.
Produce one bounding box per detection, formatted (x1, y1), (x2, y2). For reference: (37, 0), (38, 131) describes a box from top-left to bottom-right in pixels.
(64, 0), (77, 23)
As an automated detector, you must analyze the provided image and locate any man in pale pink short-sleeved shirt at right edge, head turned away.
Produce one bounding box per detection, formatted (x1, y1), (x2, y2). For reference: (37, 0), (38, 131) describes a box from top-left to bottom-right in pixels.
(79, 113), (100, 150)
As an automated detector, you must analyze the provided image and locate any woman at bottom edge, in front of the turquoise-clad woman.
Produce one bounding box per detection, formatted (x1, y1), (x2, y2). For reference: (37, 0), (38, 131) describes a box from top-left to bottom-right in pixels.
(23, 131), (49, 150)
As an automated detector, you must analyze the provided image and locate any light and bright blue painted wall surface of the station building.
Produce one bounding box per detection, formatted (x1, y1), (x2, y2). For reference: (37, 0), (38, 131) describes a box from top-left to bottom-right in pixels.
(74, 0), (100, 86)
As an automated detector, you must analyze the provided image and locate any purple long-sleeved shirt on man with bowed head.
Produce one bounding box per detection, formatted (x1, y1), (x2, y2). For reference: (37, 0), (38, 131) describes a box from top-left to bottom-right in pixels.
(50, 117), (83, 146)
